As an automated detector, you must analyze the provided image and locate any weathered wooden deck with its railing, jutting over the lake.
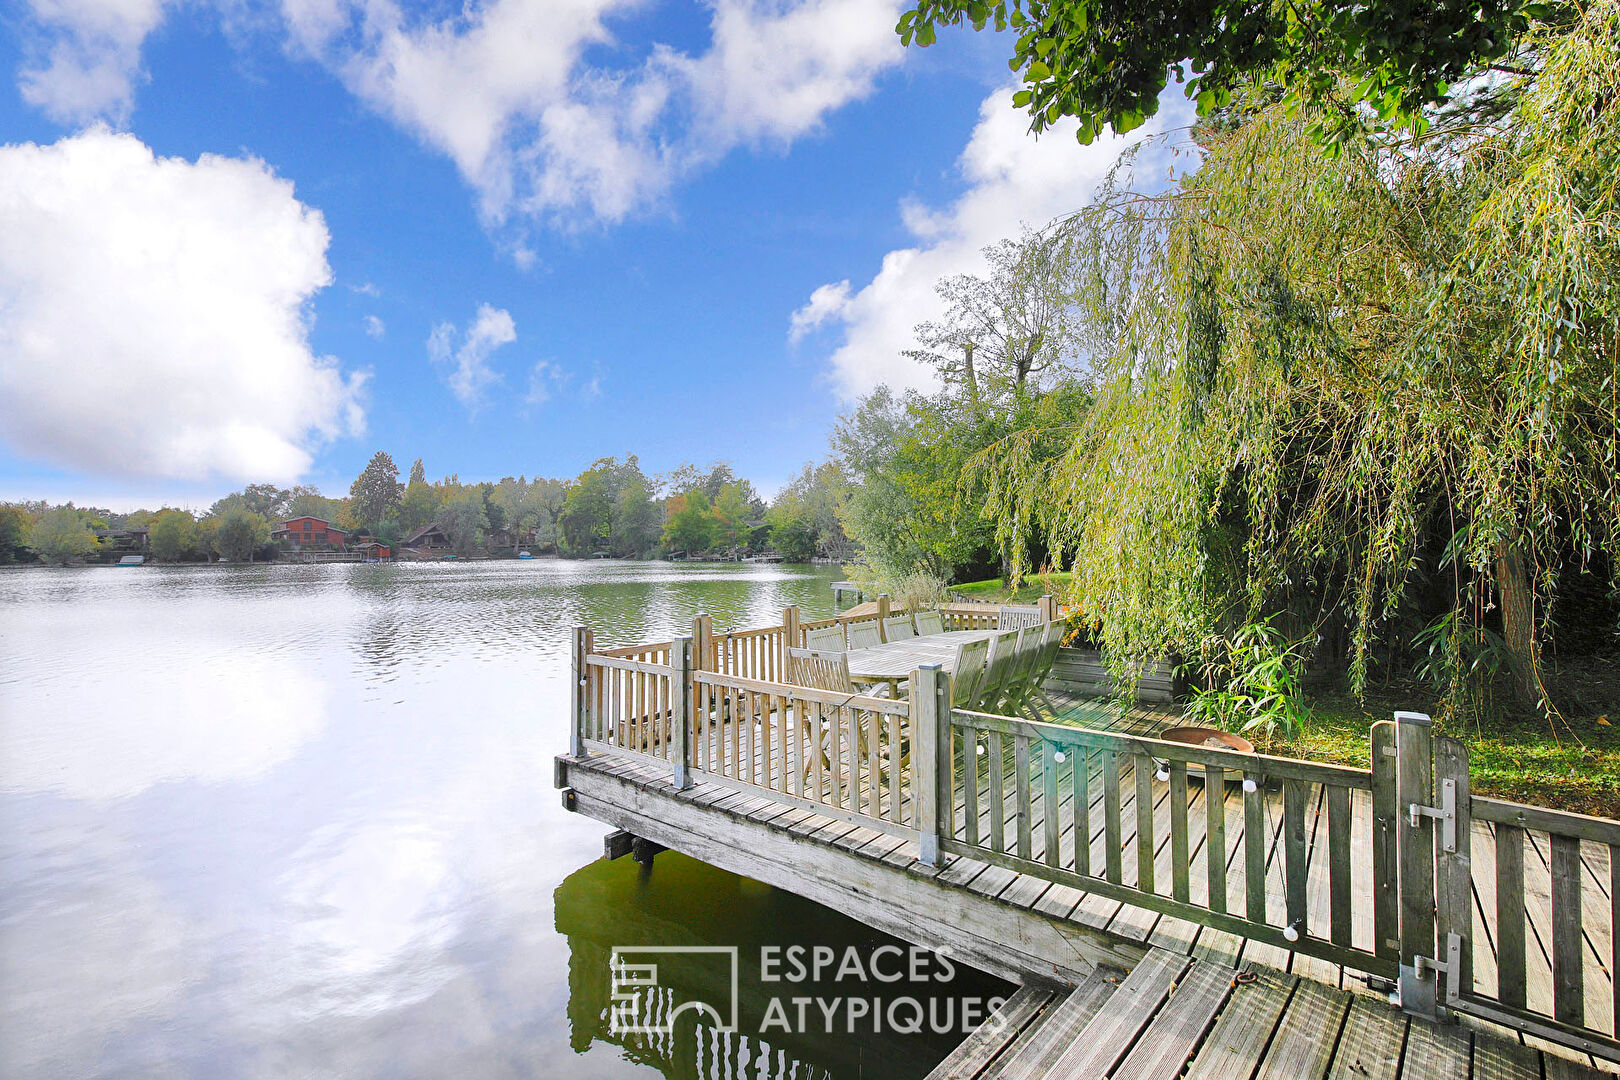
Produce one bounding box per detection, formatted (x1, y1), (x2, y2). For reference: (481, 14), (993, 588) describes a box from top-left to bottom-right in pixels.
(557, 610), (1620, 1080)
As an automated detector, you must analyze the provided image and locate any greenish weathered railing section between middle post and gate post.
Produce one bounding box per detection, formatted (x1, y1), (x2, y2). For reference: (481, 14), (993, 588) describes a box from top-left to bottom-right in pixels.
(938, 711), (1396, 978)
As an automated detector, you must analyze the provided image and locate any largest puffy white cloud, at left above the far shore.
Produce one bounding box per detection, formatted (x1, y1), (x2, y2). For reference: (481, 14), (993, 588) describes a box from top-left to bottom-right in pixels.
(0, 128), (365, 483)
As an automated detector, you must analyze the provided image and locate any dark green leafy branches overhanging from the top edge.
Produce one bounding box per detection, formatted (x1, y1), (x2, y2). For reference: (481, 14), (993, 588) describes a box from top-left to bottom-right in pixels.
(896, 0), (1542, 144)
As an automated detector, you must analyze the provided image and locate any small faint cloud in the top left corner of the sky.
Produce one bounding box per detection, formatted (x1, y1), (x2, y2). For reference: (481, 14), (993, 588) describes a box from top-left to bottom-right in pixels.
(18, 0), (168, 123)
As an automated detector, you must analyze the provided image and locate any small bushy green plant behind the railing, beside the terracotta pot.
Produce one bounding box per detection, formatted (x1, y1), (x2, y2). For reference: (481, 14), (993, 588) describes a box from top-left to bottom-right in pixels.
(1186, 620), (1311, 740)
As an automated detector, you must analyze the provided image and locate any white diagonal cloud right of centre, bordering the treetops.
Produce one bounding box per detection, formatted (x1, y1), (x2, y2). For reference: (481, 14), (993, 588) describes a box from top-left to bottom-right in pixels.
(800, 84), (1192, 398)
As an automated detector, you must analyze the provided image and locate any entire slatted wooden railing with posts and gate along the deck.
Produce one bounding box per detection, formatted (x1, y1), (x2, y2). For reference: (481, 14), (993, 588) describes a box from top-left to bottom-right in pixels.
(572, 609), (1620, 1061)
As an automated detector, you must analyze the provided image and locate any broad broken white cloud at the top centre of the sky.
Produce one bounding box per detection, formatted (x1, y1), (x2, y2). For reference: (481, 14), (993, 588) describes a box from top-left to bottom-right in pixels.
(284, 0), (902, 222)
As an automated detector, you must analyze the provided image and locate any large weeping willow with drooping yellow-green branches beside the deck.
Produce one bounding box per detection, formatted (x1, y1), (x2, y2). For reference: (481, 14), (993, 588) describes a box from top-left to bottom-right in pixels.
(977, 0), (1620, 706)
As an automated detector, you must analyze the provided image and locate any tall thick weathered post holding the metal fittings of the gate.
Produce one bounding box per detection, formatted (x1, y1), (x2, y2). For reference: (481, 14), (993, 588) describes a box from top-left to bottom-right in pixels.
(1395, 712), (1439, 1017)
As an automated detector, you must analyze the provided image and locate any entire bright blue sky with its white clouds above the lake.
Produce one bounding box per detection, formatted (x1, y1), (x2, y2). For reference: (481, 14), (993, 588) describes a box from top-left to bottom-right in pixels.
(0, 0), (1175, 508)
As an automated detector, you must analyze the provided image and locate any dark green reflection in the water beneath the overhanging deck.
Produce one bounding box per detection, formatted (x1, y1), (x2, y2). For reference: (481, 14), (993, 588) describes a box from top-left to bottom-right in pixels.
(556, 852), (1011, 1080)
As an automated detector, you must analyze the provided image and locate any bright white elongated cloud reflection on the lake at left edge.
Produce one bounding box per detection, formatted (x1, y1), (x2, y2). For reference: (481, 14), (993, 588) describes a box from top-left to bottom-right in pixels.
(0, 654), (327, 800)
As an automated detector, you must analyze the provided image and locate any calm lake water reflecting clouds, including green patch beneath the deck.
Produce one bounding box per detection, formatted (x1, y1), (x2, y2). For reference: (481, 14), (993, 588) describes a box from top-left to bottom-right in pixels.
(0, 560), (1006, 1080)
